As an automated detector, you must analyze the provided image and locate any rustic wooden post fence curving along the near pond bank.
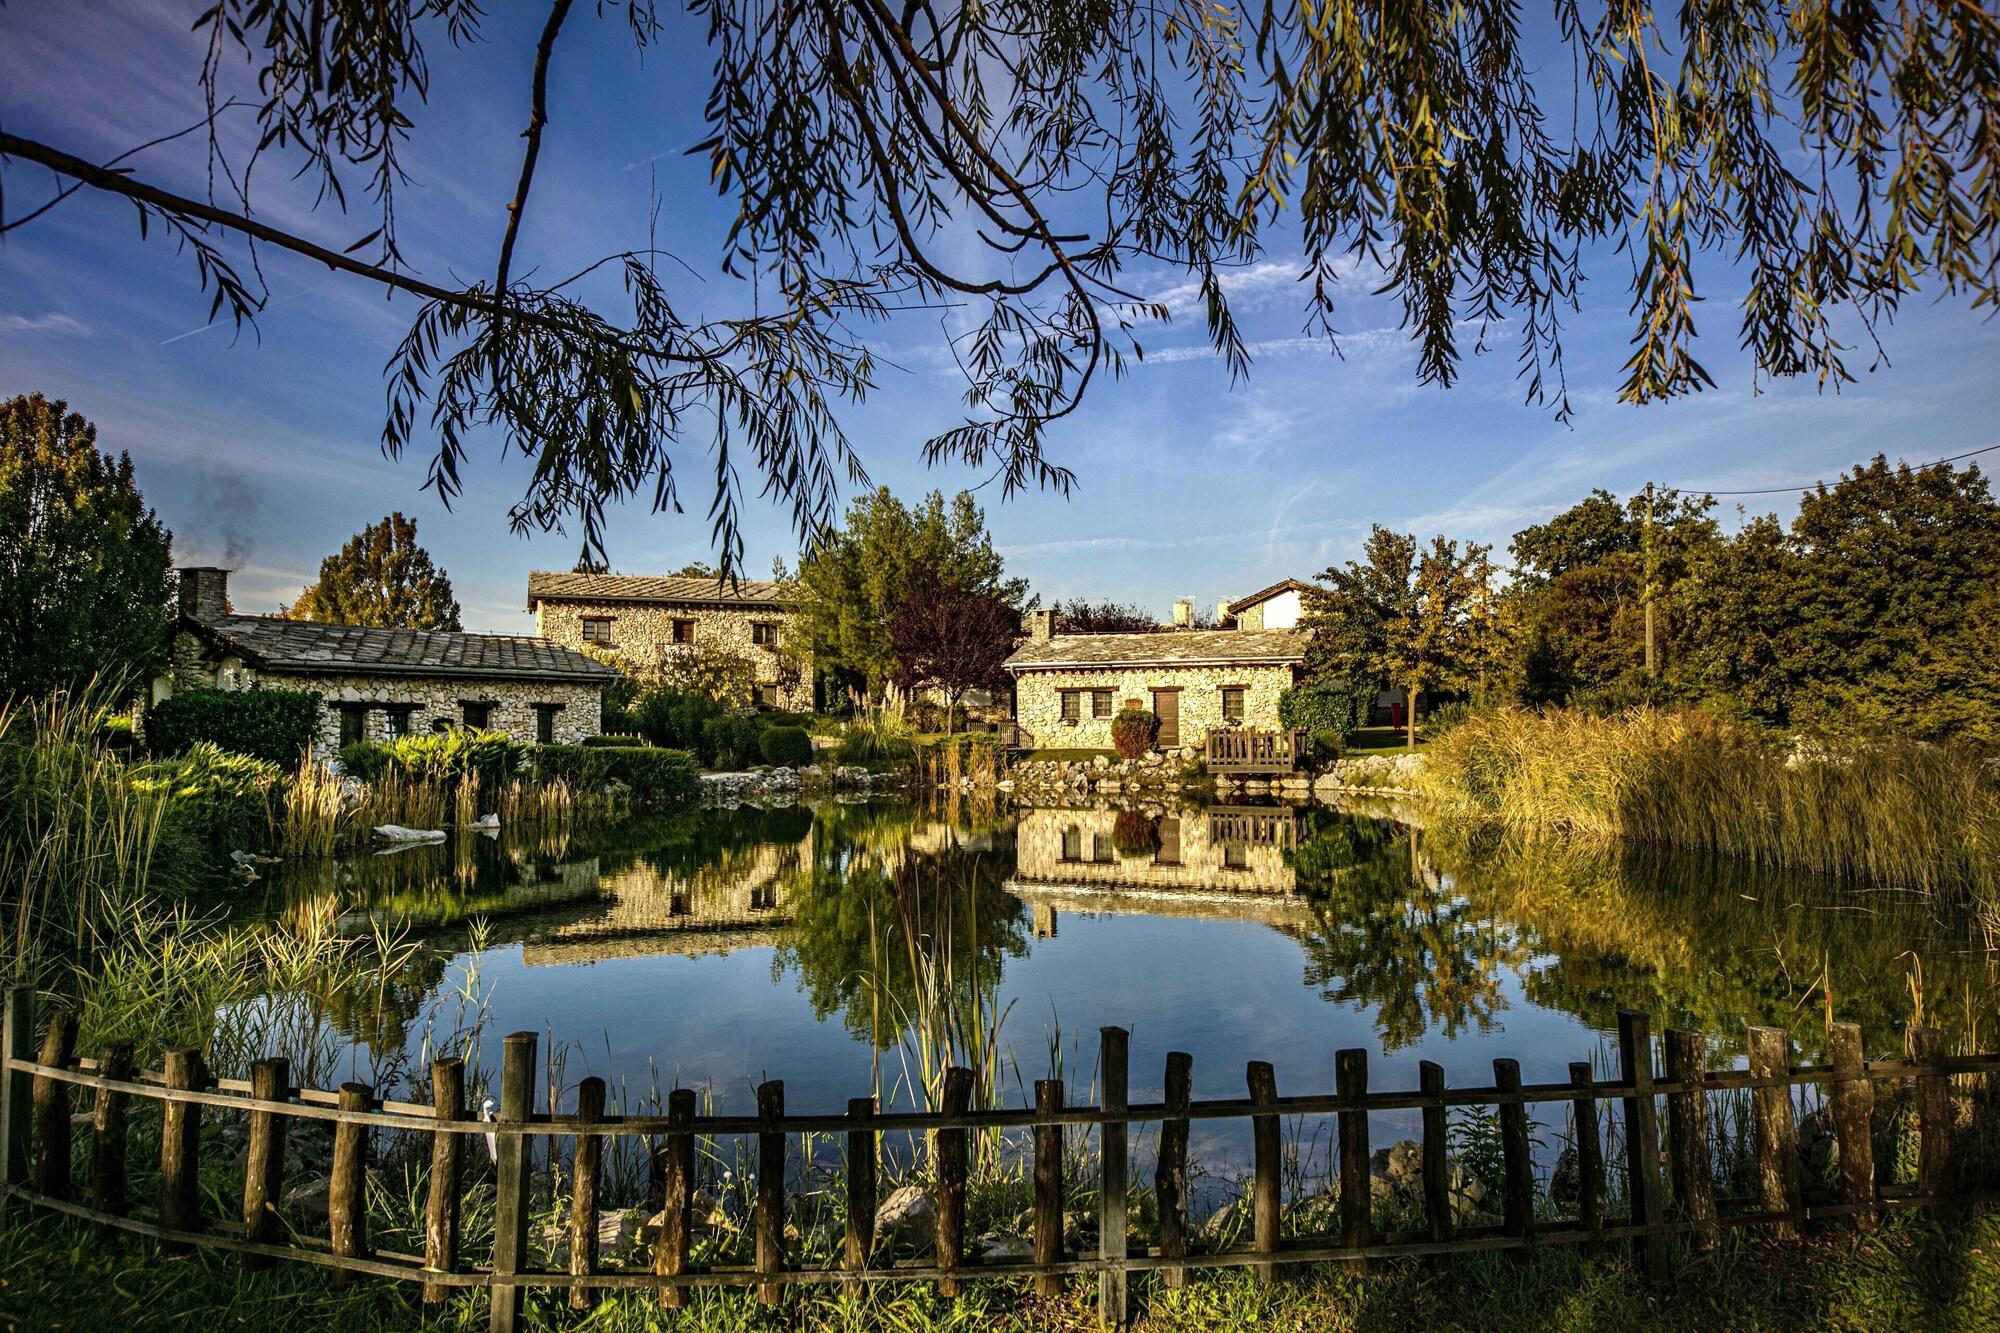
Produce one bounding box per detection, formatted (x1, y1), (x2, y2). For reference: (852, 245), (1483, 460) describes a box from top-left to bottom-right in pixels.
(0, 987), (2000, 1329)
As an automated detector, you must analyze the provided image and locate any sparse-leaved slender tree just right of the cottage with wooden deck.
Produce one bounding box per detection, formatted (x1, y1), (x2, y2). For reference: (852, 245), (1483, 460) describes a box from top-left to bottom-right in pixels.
(1304, 524), (1498, 751)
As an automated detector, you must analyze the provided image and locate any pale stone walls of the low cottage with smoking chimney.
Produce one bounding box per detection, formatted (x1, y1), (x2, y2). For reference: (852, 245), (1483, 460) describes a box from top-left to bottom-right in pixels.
(170, 632), (602, 757)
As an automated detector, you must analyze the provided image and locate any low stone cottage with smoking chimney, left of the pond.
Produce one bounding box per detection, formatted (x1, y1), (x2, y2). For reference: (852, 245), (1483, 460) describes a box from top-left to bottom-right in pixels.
(152, 568), (618, 755)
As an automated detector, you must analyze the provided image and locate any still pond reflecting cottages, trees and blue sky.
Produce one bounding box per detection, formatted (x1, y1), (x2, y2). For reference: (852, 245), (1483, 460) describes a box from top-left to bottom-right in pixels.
(254, 788), (1996, 1141)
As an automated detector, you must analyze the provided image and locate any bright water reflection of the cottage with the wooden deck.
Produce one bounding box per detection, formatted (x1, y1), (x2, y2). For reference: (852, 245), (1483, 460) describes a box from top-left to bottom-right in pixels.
(1006, 807), (1310, 937)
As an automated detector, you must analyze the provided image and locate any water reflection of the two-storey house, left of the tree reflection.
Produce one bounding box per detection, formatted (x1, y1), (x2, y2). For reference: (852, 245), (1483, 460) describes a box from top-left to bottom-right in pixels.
(522, 837), (812, 967)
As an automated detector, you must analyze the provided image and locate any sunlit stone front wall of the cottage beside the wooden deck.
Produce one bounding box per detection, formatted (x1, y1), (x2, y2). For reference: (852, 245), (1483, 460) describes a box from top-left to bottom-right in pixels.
(1014, 667), (1292, 751)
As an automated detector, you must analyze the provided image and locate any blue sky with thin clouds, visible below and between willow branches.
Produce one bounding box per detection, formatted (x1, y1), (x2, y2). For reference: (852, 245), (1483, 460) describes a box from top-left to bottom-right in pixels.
(0, 0), (2000, 630)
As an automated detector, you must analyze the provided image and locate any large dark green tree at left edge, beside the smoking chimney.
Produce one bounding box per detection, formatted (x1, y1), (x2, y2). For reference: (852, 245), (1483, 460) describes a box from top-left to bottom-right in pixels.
(0, 394), (172, 699)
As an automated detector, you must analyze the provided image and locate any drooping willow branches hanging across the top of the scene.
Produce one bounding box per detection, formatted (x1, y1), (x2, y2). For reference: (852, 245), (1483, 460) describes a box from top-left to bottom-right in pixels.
(0, 0), (2000, 556)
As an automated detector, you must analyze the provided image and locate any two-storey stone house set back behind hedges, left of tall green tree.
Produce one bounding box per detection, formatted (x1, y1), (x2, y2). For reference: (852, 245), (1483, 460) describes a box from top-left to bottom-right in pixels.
(528, 570), (812, 713)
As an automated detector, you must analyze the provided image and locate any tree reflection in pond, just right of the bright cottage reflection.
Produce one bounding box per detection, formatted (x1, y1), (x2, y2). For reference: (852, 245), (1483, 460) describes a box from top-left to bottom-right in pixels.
(1292, 811), (1528, 1051)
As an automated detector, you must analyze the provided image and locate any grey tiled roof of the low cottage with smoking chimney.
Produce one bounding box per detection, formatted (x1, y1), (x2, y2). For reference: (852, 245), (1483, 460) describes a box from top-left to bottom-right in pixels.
(194, 616), (618, 685)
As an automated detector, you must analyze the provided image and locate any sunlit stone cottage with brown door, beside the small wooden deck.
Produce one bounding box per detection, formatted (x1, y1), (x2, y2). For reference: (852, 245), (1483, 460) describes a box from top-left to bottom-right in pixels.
(1006, 610), (1306, 749)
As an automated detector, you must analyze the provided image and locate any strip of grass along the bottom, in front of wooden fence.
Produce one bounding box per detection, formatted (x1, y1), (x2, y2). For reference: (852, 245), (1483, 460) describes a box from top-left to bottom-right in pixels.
(0, 1203), (2000, 1333)
